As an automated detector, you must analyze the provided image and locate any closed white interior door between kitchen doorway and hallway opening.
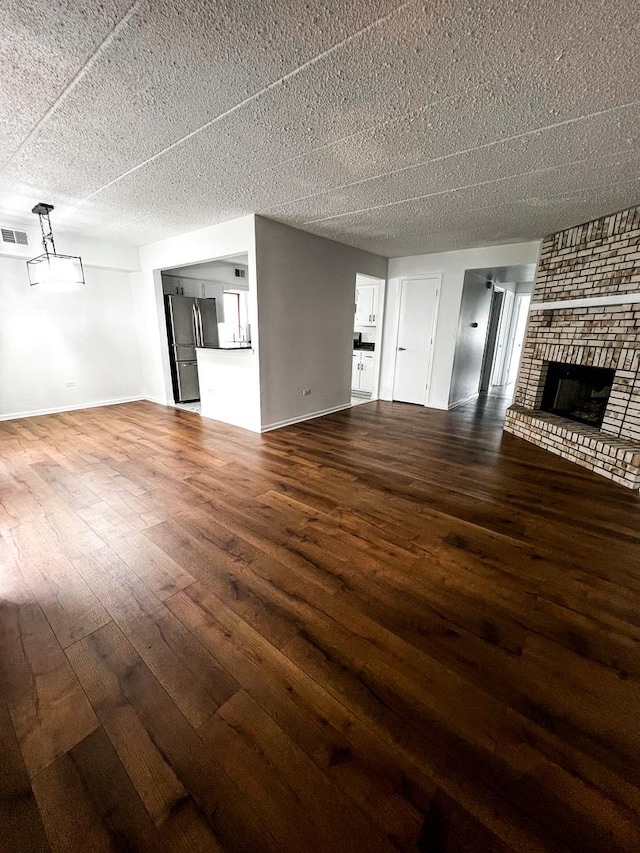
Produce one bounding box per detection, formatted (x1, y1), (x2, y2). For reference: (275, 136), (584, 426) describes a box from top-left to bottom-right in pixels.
(393, 276), (440, 406)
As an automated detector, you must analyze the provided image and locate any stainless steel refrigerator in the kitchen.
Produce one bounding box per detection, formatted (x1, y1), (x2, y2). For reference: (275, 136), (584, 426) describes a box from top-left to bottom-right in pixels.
(165, 294), (218, 403)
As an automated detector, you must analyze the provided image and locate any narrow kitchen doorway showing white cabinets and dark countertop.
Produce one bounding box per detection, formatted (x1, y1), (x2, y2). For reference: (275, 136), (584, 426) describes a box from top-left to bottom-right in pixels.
(351, 273), (385, 406)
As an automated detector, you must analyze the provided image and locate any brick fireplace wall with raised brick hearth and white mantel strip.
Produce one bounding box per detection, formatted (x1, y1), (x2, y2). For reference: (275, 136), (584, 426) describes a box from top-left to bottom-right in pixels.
(505, 207), (640, 489)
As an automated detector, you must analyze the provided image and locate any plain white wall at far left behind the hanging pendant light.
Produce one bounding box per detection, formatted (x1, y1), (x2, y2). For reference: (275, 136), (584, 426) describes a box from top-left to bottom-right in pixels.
(0, 253), (142, 419)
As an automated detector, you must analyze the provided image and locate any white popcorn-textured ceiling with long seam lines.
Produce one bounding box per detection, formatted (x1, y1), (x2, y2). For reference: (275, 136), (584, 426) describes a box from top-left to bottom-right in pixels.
(0, 0), (640, 256)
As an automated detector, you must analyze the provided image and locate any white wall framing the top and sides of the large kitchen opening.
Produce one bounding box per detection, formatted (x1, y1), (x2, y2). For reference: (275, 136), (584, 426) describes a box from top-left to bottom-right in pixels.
(133, 216), (259, 420)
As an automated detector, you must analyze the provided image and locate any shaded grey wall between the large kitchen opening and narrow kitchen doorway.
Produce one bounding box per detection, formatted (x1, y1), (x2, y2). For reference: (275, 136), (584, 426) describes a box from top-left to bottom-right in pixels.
(256, 216), (387, 429)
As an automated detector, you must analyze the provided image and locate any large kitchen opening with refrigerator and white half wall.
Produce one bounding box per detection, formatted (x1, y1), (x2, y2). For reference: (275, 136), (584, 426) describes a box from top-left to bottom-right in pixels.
(162, 255), (255, 423)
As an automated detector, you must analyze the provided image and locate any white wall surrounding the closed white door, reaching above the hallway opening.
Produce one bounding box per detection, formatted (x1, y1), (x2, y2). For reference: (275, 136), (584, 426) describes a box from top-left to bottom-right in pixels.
(380, 242), (540, 409)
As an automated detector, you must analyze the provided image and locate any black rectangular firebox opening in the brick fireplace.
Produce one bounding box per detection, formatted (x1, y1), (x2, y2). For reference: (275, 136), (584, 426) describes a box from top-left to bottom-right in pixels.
(540, 361), (615, 427)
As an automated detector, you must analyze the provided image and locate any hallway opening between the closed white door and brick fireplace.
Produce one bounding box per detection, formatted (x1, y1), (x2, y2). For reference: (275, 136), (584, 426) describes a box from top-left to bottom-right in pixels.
(449, 264), (535, 409)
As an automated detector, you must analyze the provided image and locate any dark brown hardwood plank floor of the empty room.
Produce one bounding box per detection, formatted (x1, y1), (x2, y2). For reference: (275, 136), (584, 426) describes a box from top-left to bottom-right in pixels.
(0, 398), (640, 853)
